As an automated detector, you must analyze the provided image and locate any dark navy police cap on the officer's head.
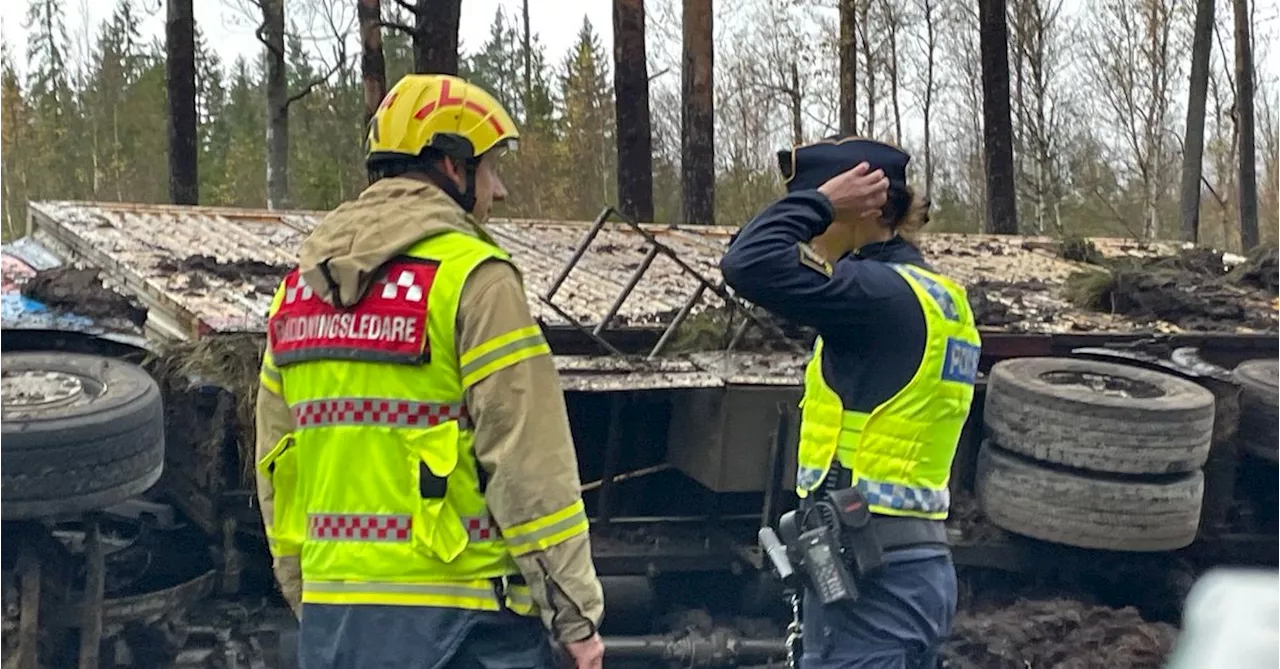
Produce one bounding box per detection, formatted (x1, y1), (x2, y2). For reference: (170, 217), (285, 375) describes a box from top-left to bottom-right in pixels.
(778, 136), (911, 193)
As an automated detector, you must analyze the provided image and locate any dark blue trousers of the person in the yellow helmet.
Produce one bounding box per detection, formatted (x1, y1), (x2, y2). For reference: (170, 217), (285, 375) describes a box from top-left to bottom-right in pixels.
(298, 604), (557, 669)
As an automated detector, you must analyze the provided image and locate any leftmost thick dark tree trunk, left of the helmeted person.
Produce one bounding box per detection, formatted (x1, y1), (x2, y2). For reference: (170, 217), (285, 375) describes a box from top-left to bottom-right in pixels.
(165, 0), (200, 205)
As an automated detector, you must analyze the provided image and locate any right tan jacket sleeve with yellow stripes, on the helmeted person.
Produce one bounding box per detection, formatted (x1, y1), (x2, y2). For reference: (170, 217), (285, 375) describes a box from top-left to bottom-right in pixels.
(458, 261), (604, 642)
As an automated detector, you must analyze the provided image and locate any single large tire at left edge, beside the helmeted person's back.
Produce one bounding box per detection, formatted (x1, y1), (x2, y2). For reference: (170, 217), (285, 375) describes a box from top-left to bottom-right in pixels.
(0, 352), (164, 521)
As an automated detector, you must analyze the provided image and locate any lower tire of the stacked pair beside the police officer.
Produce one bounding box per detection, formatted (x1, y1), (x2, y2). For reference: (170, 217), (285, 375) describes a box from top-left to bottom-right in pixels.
(975, 441), (1204, 551)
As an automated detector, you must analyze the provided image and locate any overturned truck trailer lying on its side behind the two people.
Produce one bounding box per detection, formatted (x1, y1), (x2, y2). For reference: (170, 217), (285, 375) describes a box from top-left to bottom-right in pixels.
(0, 202), (1280, 665)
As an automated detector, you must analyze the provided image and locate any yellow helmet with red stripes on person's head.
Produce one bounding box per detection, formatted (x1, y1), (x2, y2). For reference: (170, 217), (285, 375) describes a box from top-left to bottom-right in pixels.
(367, 74), (520, 166)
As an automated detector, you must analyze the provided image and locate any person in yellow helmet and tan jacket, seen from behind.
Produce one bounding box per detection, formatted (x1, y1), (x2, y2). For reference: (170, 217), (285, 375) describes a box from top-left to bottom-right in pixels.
(257, 74), (604, 669)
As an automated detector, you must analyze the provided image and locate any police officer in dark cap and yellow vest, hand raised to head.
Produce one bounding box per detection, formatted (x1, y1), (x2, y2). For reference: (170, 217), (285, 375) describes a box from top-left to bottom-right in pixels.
(721, 137), (980, 669)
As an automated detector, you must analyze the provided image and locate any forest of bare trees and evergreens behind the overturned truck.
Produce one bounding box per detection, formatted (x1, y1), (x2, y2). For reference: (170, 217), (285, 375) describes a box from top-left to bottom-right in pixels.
(0, 0), (1280, 249)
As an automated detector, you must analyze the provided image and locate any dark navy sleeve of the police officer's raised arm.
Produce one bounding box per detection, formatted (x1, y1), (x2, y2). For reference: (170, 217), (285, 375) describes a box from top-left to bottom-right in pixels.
(721, 191), (897, 336)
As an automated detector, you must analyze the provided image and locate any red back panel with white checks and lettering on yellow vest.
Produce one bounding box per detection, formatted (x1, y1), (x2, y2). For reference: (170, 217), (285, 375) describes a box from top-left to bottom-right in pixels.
(268, 260), (439, 365)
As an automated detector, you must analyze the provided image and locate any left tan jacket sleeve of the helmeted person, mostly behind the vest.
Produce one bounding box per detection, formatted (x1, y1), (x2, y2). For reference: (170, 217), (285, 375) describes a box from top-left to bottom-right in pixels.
(253, 287), (302, 614)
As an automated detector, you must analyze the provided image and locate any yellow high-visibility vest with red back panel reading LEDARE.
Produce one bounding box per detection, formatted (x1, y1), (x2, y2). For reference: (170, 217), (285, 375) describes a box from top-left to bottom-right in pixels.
(259, 233), (542, 615)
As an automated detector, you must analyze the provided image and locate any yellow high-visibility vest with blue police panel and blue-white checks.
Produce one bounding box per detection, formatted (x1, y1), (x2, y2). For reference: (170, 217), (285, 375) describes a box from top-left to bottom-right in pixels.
(796, 265), (982, 519)
